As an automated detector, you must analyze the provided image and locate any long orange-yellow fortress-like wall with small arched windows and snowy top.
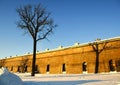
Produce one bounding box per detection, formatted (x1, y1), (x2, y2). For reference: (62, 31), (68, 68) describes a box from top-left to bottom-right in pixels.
(0, 37), (120, 74)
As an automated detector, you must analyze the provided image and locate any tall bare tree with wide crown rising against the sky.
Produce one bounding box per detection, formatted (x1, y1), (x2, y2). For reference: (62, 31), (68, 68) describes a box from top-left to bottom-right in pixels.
(16, 4), (56, 76)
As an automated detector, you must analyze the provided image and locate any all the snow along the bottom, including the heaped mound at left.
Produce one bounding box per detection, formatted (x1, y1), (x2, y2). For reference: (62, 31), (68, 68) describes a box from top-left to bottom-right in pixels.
(0, 68), (120, 85)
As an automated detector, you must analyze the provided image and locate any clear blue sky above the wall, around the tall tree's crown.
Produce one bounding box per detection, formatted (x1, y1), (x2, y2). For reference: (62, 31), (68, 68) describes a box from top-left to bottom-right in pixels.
(0, 0), (120, 58)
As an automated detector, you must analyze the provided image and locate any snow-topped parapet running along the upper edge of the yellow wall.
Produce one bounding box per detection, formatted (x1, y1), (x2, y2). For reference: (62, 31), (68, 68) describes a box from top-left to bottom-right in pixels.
(1, 36), (120, 59)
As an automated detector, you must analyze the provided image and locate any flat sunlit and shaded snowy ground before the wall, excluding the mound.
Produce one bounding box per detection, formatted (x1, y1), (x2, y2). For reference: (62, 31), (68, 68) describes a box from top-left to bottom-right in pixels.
(17, 73), (120, 85)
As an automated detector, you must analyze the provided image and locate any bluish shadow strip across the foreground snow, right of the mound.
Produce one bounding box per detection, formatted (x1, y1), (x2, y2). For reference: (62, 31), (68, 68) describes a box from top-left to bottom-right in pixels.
(24, 80), (101, 85)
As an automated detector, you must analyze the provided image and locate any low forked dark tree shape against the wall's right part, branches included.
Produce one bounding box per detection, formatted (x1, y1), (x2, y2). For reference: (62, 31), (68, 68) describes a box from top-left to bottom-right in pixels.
(89, 39), (107, 73)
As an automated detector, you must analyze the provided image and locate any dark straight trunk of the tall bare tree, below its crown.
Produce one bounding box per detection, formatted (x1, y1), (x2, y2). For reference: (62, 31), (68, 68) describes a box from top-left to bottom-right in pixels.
(31, 38), (37, 76)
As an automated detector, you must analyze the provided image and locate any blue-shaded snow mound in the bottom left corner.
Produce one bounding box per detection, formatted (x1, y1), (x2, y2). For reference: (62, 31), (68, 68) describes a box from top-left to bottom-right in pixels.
(0, 68), (23, 85)
